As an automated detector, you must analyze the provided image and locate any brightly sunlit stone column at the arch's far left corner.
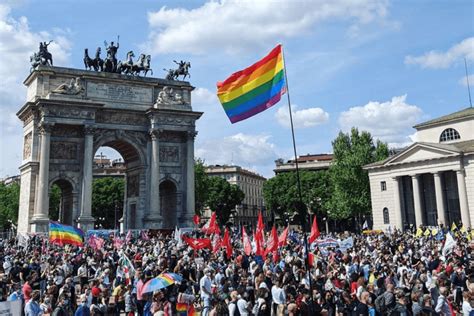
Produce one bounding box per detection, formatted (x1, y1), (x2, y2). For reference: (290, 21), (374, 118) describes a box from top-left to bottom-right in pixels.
(31, 123), (52, 232)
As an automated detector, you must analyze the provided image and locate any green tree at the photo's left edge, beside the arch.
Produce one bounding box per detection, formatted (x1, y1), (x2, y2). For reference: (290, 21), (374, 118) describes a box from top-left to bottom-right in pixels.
(0, 183), (20, 230)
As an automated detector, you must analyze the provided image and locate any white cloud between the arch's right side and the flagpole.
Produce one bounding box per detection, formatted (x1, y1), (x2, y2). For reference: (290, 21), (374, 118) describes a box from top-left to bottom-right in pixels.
(196, 133), (277, 169)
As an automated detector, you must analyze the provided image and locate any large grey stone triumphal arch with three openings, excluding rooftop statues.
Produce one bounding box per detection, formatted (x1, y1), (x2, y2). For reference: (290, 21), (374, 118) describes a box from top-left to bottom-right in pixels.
(17, 65), (202, 232)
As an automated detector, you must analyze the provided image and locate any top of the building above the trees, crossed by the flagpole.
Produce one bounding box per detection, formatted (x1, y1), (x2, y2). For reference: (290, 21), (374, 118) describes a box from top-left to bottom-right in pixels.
(273, 154), (333, 174)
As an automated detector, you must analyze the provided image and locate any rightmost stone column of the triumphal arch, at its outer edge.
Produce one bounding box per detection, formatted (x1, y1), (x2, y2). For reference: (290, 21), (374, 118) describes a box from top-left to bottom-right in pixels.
(183, 131), (197, 227)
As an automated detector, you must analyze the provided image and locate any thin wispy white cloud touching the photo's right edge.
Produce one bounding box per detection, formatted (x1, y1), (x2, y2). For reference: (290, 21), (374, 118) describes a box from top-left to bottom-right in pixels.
(405, 37), (474, 69)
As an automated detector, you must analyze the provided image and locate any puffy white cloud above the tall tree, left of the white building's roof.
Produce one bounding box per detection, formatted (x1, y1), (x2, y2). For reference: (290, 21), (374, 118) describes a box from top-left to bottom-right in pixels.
(339, 95), (423, 145)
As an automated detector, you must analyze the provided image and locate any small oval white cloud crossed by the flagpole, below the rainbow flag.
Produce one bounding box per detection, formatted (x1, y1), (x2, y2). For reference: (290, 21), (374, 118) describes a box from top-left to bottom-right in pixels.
(275, 106), (329, 128)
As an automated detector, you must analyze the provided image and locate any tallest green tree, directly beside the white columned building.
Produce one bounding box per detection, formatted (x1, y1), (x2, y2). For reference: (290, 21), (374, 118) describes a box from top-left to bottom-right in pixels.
(327, 127), (388, 223)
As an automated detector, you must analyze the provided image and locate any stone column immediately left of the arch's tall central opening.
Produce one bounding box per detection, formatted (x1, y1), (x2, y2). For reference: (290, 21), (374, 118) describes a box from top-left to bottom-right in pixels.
(78, 125), (94, 231)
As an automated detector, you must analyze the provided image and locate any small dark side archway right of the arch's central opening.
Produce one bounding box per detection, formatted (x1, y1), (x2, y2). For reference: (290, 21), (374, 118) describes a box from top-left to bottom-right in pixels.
(160, 177), (179, 228)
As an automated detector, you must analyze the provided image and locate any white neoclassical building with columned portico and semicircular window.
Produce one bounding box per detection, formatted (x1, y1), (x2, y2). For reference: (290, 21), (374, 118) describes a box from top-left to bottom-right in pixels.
(364, 108), (474, 229)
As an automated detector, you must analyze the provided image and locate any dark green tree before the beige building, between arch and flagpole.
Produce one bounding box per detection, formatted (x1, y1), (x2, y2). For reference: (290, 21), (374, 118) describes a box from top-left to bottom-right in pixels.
(205, 177), (245, 225)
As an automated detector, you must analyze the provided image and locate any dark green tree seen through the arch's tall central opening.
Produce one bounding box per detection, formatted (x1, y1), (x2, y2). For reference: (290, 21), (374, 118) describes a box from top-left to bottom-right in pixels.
(92, 177), (125, 228)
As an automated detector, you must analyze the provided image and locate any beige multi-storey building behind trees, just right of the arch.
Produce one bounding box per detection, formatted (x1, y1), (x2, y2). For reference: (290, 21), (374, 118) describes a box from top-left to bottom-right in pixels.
(205, 165), (268, 225)
